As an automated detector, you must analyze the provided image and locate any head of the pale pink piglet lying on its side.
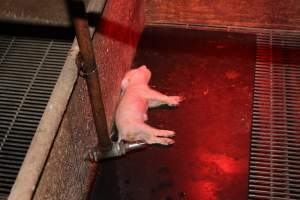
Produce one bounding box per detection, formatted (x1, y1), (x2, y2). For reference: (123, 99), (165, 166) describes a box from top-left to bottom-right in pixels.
(121, 65), (151, 90)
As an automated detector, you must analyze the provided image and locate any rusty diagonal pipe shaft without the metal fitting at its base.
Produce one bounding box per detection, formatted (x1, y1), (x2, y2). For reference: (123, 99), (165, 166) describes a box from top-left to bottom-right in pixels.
(70, 0), (112, 150)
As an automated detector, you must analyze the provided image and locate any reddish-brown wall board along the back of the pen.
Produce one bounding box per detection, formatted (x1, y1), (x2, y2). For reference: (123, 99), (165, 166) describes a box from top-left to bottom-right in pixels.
(146, 0), (300, 30)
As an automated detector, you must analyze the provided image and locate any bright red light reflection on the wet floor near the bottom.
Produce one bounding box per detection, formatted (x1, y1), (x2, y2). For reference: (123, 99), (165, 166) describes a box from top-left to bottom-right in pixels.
(188, 152), (248, 200)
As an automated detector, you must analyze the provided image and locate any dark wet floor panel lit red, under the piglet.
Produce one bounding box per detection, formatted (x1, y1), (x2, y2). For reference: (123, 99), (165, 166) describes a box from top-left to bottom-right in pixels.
(93, 28), (256, 200)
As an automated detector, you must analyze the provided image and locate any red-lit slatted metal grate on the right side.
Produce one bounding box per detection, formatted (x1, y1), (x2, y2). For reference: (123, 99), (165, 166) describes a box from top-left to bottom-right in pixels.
(249, 33), (300, 200)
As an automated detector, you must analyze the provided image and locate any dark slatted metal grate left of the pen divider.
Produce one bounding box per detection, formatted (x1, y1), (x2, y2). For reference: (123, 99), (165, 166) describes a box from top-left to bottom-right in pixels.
(0, 35), (71, 199)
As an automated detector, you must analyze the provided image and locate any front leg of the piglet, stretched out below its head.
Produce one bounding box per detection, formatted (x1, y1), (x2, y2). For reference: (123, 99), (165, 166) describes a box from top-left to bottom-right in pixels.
(147, 89), (184, 108)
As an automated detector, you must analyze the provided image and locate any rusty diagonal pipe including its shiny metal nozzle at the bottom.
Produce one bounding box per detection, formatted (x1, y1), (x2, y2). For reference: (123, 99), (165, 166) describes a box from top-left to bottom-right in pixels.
(70, 0), (146, 162)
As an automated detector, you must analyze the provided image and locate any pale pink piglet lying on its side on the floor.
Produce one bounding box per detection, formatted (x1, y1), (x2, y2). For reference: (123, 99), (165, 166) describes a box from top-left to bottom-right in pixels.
(115, 65), (183, 145)
